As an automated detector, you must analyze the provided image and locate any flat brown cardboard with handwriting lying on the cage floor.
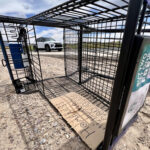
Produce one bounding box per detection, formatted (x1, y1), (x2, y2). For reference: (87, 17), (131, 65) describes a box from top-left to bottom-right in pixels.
(51, 92), (107, 149)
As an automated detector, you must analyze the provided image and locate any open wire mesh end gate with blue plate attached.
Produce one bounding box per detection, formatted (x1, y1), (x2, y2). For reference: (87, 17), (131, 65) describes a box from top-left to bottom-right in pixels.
(0, 22), (44, 93)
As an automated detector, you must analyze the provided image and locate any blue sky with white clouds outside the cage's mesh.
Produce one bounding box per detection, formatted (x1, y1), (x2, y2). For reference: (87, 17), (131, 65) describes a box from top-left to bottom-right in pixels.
(0, 0), (68, 42)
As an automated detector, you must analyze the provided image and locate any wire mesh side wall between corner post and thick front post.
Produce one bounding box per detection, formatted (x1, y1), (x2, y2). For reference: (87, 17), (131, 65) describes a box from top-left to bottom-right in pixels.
(82, 18), (125, 102)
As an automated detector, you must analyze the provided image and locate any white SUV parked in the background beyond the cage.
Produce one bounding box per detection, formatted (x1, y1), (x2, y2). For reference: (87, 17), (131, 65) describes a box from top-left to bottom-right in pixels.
(37, 37), (63, 51)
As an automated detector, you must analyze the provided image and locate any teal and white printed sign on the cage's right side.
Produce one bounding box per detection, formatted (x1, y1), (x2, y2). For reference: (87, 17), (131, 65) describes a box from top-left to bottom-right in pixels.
(122, 38), (150, 128)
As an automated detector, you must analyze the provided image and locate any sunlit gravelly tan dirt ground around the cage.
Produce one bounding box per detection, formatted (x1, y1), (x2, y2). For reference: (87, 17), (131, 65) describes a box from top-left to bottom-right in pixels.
(0, 55), (150, 150)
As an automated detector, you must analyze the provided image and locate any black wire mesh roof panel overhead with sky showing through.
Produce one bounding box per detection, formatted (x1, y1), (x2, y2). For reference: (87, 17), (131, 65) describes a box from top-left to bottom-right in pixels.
(26, 0), (129, 27)
